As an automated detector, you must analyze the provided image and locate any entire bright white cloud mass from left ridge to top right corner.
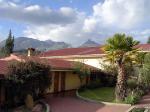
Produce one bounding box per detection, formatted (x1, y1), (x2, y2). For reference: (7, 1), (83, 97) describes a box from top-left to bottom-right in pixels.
(25, 0), (150, 45)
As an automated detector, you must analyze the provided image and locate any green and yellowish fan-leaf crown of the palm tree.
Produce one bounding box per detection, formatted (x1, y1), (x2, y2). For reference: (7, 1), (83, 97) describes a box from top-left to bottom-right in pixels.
(103, 34), (139, 63)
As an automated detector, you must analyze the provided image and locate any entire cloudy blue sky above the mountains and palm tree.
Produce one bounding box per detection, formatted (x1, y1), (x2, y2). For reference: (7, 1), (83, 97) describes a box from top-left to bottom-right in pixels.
(0, 0), (150, 46)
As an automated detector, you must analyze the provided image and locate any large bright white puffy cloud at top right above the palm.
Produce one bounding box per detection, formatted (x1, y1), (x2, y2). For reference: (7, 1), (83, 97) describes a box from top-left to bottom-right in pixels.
(84, 0), (150, 30)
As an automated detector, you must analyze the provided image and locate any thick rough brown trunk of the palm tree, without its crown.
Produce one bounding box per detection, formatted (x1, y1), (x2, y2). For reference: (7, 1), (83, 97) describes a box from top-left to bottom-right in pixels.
(116, 63), (126, 101)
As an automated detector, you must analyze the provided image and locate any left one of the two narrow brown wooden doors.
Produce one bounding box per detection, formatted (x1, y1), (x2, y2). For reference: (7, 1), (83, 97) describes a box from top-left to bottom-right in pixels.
(54, 72), (59, 93)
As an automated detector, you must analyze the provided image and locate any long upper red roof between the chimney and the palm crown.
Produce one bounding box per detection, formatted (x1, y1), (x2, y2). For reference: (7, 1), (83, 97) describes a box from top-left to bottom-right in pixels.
(40, 47), (104, 57)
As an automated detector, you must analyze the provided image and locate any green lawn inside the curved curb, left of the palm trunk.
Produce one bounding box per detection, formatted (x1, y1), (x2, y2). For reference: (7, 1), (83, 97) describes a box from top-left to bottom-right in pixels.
(79, 87), (115, 102)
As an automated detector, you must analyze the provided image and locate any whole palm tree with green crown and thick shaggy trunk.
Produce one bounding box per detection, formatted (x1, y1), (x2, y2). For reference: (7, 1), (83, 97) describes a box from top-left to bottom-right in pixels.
(104, 34), (139, 101)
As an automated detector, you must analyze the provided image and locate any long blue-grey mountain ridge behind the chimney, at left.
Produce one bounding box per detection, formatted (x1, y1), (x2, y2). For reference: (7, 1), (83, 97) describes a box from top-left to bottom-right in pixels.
(0, 37), (71, 51)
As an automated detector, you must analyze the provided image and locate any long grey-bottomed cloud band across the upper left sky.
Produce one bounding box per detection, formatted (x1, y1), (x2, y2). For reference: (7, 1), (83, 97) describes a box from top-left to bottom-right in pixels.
(0, 1), (76, 25)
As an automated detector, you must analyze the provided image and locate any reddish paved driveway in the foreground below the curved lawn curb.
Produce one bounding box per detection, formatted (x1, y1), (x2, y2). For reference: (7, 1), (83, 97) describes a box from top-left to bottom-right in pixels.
(46, 97), (129, 112)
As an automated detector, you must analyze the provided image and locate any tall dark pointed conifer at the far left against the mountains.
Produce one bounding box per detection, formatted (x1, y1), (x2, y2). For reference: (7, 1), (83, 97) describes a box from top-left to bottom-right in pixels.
(5, 30), (14, 55)
